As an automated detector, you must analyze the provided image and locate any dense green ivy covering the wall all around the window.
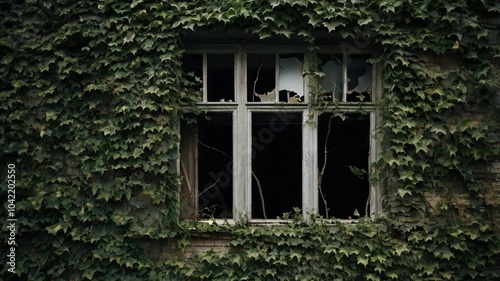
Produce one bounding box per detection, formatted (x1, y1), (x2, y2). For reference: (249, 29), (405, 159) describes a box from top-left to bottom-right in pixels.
(0, 0), (500, 280)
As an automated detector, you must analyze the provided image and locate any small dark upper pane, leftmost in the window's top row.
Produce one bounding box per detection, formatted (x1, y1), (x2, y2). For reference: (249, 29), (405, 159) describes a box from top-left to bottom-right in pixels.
(207, 54), (234, 102)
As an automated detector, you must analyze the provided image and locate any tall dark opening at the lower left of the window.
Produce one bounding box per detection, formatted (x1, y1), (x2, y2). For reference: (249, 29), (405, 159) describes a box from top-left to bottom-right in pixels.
(197, 113), (233, 218)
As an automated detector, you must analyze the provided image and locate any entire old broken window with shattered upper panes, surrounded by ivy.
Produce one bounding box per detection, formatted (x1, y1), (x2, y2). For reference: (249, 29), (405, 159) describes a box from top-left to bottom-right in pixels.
(179, 44), (379, 222)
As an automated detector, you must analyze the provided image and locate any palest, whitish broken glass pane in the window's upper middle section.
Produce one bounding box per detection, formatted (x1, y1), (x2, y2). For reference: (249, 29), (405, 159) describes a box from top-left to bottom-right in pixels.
(278, 54), (304, 103)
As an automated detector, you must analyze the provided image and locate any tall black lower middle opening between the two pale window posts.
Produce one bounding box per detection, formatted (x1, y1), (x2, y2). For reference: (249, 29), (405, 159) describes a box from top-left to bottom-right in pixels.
(252, 112), (302, 219)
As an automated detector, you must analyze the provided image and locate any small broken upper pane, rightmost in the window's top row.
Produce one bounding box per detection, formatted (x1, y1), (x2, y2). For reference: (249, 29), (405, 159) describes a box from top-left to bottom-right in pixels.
(347, 55), (372, 101)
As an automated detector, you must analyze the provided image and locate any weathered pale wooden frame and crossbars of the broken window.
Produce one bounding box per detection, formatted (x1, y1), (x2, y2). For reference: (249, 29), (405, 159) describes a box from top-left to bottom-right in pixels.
(182, 44), (382, 224)
